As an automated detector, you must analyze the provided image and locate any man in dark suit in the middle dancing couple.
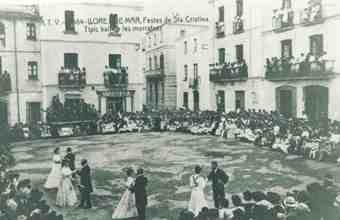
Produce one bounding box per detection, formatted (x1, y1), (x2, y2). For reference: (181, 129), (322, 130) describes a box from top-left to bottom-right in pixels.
(134, 168), (148, 220)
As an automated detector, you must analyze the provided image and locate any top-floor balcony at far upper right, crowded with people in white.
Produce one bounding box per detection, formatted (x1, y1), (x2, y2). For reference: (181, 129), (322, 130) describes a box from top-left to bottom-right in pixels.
(300, 2), (324, 26)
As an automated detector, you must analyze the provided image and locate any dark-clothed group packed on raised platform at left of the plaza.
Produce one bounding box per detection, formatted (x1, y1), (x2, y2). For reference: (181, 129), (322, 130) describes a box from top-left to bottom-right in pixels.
(46, 96), (98, 122)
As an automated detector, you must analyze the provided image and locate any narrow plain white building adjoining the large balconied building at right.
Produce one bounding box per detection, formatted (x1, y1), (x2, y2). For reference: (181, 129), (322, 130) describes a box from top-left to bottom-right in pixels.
(176, 27), (211, 111)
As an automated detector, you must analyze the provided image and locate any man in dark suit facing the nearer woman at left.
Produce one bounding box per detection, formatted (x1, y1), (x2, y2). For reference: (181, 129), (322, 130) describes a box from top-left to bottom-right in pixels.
(77, 159), (93, 209)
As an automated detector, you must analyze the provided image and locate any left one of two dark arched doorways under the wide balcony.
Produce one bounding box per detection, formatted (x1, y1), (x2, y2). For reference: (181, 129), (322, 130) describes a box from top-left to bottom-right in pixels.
(275, 86), (296, 117)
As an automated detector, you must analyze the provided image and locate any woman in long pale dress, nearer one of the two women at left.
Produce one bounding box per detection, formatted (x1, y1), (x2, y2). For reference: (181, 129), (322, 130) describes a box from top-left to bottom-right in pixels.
(56, 160), (77, 207)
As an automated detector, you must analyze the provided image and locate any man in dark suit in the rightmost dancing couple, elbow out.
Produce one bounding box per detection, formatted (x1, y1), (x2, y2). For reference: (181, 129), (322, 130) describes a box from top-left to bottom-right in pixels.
(208, 161), (229, 208)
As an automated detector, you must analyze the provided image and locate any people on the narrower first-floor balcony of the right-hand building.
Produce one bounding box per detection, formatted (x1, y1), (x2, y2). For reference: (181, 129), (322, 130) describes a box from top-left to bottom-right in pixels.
(211, 59), (248, 79)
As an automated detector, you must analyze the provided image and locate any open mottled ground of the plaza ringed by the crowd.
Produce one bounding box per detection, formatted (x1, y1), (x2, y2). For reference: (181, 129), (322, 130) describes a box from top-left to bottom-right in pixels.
(12, 132), (339, 220)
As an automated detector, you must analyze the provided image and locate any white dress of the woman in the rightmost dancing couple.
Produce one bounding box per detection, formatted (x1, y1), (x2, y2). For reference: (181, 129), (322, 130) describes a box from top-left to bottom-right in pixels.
(188, 174), (208, 217)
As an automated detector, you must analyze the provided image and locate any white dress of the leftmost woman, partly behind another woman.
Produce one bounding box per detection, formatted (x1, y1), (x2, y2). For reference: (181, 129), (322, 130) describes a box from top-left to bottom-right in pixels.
(44, 154), (61, 189)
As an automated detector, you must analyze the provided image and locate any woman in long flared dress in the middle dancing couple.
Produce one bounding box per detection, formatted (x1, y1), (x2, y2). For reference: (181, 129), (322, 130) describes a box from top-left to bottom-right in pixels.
(112, 168), (138, 219)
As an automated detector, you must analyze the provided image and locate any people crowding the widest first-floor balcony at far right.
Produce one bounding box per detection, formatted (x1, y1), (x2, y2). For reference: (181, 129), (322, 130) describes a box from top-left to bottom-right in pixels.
(265, 52), (333, 77)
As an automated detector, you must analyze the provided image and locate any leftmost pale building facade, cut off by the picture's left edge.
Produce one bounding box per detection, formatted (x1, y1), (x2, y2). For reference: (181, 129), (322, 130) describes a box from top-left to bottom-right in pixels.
(0, 6), (42, 124)
